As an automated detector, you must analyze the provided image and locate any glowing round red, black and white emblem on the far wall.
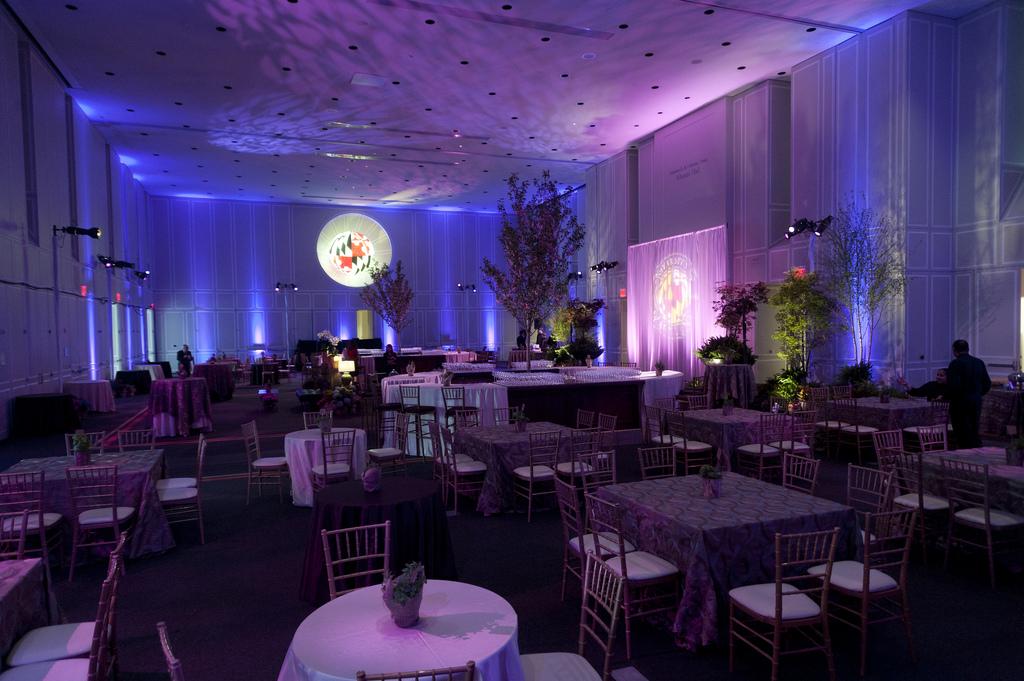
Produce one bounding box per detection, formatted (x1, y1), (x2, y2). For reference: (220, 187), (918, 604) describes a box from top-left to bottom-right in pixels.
(316, 213), (391, 289)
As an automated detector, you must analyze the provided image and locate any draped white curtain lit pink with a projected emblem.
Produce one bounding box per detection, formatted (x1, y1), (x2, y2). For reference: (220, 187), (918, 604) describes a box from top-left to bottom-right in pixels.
(627, 225), (727, 376)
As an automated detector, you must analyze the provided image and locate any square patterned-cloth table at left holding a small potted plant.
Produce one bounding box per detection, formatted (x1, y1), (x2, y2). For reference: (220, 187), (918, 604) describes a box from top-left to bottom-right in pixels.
(6, 450), (174, 558)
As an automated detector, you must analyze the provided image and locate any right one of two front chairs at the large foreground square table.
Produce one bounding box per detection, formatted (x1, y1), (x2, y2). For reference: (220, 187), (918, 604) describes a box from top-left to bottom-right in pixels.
(807, 509), (918, 676)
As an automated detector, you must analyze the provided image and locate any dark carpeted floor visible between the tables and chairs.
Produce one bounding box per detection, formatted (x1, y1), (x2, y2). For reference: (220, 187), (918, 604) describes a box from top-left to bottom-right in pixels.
(0, 386), (1024, 681)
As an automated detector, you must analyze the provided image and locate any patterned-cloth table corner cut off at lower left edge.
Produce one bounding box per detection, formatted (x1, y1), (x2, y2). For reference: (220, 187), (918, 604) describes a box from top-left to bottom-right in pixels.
(0, 558), (60, 657)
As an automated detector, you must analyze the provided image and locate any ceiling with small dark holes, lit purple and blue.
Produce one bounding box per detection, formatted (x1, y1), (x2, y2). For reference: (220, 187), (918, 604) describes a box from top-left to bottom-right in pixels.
(8, 0), (987, 210)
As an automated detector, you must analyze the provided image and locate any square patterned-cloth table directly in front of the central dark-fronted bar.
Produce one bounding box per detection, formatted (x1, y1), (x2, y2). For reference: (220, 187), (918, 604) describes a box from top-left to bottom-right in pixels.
(455, 421), (572, 514)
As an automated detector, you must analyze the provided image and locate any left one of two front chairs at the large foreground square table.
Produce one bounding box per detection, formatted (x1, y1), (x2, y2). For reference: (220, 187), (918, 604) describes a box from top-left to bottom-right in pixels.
(729, 527), (839, 681)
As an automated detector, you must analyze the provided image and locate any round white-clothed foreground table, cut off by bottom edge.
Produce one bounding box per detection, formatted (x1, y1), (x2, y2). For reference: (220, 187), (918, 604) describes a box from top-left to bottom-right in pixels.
(278, 580), (523, 681)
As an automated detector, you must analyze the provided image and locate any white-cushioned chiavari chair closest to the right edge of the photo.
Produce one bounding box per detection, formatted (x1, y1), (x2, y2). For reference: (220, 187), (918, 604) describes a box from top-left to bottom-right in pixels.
(942, 457), (1024, 589)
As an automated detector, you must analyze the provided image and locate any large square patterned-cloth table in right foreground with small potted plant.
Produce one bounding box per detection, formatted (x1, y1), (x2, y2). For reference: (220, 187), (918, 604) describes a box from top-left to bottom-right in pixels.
(597, 473), (859, 650)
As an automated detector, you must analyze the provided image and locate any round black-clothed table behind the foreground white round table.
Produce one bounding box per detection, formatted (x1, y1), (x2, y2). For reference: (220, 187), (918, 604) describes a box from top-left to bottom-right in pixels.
(299, 477), (457, 603)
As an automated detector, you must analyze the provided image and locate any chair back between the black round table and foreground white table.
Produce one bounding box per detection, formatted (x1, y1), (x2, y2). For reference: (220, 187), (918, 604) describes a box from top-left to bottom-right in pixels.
(321, 520), (391, 600)
